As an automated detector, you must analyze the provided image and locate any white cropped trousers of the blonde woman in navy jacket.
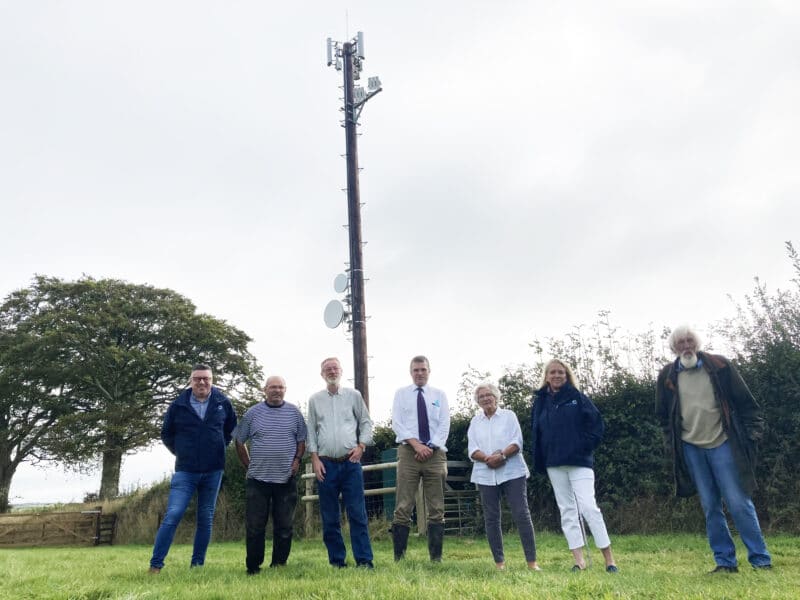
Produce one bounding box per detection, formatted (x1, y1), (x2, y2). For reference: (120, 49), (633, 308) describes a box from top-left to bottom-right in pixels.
(547, 467), (611, 550)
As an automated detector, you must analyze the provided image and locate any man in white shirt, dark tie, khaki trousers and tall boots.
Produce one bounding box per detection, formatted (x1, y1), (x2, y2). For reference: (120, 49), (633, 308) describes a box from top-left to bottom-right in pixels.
(392, 356), (450, 562)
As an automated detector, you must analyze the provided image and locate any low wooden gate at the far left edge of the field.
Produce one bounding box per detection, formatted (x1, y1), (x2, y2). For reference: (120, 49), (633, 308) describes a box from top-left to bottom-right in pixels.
(0, 507), (117, 548)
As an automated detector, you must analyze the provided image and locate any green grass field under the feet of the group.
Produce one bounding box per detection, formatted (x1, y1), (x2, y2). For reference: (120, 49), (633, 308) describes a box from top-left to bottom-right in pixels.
(0, 533), (800, 600)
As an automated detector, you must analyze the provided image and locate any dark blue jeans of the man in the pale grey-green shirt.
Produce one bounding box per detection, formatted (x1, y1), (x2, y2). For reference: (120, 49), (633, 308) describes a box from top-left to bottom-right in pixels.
(317, 459), (372, 565)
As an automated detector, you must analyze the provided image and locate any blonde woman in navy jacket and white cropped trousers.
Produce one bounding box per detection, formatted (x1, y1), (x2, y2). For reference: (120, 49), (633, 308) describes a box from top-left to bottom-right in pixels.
(531, 359), (617, 573)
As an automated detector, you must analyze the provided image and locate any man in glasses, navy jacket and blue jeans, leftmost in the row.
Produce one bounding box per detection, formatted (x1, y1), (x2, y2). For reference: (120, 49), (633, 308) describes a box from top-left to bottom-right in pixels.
(150, 364), (236, 573)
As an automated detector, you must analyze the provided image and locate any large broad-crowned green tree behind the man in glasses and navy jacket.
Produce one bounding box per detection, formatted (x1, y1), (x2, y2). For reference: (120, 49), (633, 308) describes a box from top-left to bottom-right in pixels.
(2, 276), (260, 498)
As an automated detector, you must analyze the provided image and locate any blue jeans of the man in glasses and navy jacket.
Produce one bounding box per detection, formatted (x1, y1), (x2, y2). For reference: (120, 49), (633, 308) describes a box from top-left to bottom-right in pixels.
(150, 471), (222, 569)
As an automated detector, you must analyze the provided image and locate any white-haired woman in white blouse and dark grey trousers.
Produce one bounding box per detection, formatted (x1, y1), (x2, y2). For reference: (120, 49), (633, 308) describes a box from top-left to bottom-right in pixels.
(467, 382), (541, 571)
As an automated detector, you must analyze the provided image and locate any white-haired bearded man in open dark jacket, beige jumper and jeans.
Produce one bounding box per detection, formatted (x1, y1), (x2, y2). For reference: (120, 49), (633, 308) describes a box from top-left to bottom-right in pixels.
(656, 326), (772, 573)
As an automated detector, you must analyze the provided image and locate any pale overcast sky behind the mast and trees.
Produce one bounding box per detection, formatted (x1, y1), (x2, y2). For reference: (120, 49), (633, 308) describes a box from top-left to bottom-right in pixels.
(0, 0), (800, 503)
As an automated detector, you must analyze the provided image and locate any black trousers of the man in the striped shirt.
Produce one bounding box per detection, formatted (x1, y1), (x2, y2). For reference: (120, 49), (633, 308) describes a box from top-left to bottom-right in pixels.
(245, 477), (297, 571)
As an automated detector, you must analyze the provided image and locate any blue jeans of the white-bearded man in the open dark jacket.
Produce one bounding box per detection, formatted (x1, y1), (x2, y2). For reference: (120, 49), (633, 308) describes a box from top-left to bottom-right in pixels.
(683, 441), (772, 567)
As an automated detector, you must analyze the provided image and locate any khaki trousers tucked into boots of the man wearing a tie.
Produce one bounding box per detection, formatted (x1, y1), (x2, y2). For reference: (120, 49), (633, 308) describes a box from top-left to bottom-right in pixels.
(392, 444), (447, 527)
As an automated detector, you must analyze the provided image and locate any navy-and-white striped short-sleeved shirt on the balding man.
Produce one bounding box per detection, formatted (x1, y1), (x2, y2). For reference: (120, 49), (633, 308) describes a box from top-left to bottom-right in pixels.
(236, 402), (307, 483)
